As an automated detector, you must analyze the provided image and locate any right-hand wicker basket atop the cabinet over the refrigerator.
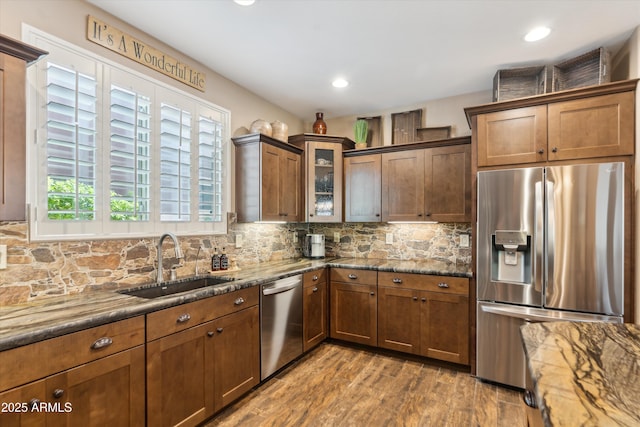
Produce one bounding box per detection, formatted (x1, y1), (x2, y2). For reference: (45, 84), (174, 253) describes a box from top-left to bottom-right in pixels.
(553, 47), (611, 92)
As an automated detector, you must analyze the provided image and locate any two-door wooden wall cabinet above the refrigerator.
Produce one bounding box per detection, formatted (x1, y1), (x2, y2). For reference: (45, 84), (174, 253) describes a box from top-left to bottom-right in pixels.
(465, 80), (637, 167)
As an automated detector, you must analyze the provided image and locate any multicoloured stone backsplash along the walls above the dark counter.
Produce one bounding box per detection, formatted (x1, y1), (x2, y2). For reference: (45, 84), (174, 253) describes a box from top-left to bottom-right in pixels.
(0, 222), (471, 307)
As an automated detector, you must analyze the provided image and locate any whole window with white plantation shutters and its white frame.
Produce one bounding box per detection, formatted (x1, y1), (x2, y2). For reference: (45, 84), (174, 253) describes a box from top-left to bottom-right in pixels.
(28, 29), (229, 240)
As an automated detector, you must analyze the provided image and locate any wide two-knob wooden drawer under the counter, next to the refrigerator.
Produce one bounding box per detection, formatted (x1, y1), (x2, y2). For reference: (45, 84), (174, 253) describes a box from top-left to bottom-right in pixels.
(378, 271), (469, 295)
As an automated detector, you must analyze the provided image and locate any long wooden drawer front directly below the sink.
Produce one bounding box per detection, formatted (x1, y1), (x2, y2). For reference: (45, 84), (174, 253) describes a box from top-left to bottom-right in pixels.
(147, 286), (259, 341)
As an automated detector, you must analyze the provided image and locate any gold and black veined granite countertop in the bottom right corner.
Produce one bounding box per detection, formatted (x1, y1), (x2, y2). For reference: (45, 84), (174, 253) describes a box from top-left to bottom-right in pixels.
(520, 322), (640, 426)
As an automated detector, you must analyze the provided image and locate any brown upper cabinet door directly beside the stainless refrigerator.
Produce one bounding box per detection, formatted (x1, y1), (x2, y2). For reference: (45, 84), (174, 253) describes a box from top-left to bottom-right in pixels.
(424, 144), (471, 222)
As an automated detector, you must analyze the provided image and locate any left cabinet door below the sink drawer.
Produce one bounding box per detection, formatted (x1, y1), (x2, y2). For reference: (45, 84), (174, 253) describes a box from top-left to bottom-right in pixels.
(146, 322), (215, 426)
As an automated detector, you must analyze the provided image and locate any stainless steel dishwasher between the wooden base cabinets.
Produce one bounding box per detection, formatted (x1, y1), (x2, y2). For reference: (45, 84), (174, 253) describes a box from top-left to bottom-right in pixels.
(260, 275), (302, 379)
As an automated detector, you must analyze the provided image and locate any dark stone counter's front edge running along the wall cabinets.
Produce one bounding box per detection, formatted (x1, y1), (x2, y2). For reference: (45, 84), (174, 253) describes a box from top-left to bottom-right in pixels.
(0, 260), (472, 351)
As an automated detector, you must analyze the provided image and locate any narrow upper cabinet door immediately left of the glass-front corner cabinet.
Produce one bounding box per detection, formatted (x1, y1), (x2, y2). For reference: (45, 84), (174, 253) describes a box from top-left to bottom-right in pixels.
(278, 150), (303, 222)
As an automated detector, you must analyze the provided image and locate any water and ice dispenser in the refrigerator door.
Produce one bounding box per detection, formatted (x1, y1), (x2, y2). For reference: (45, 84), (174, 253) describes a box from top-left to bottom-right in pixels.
(491, 230), (533, 283)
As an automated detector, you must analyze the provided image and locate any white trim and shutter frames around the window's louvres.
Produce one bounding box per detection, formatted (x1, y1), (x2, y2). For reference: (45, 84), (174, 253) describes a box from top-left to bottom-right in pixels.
(22, 24), (233, 241)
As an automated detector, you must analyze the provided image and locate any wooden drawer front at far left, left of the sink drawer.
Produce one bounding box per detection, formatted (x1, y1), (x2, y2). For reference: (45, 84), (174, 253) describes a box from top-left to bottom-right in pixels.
(0, 316), (144, 391)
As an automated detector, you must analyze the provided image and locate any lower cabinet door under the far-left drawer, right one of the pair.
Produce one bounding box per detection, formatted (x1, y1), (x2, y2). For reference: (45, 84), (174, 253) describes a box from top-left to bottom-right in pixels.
(46, 346), (145, 426)
